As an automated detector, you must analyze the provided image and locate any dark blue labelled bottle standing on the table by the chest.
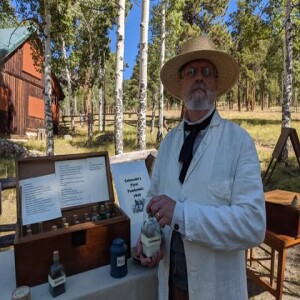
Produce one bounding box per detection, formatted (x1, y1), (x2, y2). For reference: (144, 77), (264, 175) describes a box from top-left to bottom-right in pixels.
(110, 238), (128, 278)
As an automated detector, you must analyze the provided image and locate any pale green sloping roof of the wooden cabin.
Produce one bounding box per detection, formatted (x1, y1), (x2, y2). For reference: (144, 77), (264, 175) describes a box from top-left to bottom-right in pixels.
(0, 27), (31, 63)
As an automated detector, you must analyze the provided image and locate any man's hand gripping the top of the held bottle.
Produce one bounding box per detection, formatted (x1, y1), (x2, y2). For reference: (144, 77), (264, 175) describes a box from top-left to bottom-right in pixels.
(147, 195), (176, 228)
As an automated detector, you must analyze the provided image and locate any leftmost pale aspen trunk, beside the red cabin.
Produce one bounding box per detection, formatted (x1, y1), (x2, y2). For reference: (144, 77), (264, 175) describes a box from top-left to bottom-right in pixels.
(44, 0), (54, 156)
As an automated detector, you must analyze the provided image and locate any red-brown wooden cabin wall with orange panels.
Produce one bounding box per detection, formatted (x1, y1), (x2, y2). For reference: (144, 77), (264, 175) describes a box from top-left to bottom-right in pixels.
(0, 42), (63, 136)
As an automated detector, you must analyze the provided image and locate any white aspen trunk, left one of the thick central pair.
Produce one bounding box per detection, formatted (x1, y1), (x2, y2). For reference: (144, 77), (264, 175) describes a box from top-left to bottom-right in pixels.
(115, 0), (125, 154)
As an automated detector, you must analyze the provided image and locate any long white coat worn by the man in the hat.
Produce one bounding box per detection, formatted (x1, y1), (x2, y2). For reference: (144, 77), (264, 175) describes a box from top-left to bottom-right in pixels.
(148, 111), (266, 300)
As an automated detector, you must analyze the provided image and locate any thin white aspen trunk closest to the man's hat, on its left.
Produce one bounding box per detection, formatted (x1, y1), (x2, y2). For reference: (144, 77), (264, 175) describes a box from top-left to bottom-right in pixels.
(156, 3), (166, 142)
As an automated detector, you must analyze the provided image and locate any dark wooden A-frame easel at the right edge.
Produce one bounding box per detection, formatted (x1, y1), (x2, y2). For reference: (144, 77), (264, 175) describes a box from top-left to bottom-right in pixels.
(263, 128), (300, 184)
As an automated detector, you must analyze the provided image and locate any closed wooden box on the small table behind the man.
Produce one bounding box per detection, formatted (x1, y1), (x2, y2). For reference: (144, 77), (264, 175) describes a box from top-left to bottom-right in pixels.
(265, 190), (300, 238)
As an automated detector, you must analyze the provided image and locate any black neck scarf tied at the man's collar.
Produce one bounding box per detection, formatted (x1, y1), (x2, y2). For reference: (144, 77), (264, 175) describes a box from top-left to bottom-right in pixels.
(179, 110), (215, 183)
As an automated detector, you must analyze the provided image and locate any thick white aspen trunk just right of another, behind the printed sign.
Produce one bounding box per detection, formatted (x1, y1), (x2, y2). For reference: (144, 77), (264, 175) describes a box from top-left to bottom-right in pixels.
(138, 0), (149, 150)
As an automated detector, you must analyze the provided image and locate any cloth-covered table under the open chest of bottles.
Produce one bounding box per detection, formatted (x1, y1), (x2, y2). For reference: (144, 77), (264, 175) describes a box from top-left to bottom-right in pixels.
(0, 250), (158, 300)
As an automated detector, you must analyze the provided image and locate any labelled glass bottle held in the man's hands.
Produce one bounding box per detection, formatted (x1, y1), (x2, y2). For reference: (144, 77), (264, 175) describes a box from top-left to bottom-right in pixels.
(141, 215), (161, 257)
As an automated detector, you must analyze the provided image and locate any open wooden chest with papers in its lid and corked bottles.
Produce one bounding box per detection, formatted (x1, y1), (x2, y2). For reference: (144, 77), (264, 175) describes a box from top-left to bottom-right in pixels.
(14, 152), (130, 286)
